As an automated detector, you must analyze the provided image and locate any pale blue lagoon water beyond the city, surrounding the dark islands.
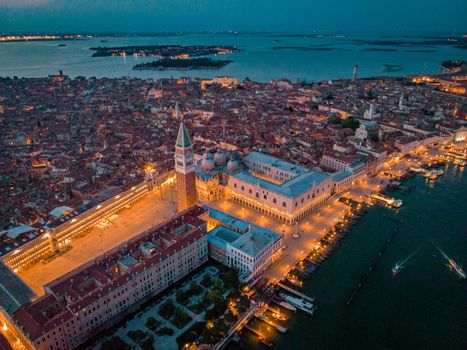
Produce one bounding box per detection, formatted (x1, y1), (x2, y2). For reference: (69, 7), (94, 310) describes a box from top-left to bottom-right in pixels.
(0, 34), (467, 82)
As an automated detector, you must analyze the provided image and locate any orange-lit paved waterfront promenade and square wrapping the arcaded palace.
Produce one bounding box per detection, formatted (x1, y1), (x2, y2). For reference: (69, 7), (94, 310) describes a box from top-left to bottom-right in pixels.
(211, 147), (450, 282)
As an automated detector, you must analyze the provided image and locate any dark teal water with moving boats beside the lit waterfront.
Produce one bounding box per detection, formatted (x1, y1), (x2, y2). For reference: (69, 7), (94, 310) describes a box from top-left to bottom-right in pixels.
(242, 166), (467, 349)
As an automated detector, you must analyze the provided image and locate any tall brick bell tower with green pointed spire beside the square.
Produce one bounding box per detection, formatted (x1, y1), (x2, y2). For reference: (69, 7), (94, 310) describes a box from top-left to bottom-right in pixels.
(175, 120), (196, 212)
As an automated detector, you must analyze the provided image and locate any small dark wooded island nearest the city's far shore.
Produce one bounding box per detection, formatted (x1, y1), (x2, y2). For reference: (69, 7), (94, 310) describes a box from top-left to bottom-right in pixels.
(133, 57), (232, 70)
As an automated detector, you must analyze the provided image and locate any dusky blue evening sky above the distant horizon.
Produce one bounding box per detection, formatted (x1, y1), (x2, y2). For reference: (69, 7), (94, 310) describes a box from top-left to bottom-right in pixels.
(0, 0), (467, 33)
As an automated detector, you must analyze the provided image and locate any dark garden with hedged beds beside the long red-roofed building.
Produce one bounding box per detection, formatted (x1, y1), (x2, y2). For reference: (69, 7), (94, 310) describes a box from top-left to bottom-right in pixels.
(101, 266), (250, 350)
